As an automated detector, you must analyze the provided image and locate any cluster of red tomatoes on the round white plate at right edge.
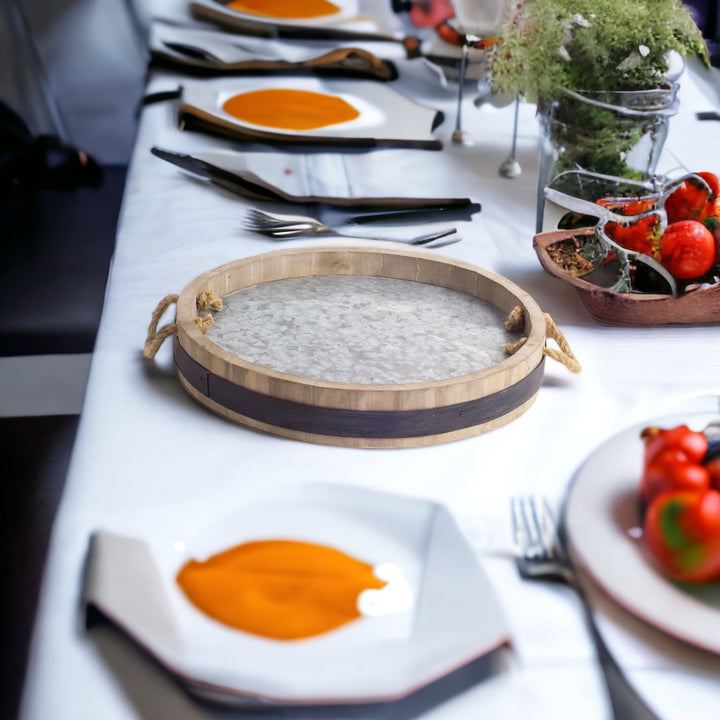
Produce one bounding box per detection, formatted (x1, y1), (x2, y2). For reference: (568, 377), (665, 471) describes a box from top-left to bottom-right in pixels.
(640, 425), (720, 583)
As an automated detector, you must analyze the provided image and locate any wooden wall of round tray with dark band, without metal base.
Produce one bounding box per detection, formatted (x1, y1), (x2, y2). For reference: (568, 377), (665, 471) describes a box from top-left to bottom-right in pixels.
(145, 247), (579, 447)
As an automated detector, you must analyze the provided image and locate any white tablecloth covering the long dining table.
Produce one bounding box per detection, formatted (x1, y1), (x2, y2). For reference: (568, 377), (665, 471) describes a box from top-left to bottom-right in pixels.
(14, 4), (720, 720)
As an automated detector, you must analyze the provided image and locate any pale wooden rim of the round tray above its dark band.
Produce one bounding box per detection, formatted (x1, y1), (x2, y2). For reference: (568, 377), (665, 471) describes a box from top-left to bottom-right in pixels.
(177, 246), (546, 410)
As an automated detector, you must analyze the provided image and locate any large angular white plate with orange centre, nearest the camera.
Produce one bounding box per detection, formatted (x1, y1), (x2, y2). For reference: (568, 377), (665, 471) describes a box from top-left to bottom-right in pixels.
(83, 483), (510, 711)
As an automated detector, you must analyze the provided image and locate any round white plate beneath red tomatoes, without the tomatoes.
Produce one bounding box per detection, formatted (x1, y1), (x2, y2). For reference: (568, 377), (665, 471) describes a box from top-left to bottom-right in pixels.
(565, 413), (720, 653)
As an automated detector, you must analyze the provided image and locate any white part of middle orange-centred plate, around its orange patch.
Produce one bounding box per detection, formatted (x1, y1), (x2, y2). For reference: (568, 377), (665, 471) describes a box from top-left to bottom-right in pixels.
(180, 77), (440, 149)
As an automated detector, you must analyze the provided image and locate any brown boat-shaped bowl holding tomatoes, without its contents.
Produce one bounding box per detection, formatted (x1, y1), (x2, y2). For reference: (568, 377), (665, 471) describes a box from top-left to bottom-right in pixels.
(533, 228), (720, 327)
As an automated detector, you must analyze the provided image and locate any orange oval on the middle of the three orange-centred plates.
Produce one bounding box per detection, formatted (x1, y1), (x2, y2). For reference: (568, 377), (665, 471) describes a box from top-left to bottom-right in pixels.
(223, 88), (360, 130)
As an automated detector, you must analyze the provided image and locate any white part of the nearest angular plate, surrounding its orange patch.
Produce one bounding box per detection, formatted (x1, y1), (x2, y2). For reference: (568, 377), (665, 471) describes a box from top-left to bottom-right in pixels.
(84, 484), (509, 704)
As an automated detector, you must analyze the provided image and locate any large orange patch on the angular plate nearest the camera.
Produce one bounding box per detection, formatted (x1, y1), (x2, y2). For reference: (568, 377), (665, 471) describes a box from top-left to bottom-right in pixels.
(177, 540), (386, 640)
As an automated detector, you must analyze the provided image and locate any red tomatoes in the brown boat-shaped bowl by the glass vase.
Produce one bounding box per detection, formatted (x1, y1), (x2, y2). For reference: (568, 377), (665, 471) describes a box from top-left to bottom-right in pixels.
(598, 172), (720, 280)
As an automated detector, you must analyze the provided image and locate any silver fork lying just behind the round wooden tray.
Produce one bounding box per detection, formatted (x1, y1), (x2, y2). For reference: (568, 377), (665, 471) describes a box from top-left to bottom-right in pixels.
(243, 208), (460, 247)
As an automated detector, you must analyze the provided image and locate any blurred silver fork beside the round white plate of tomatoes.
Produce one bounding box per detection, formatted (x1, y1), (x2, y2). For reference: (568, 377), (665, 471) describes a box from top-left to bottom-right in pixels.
(510, 496), (659, 720)
